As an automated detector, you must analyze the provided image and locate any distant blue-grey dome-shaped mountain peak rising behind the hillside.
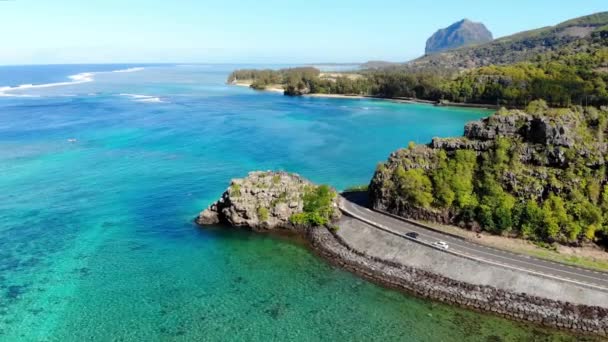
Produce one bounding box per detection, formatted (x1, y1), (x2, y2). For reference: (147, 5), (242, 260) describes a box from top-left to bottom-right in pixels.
(425, 19), (492, 54)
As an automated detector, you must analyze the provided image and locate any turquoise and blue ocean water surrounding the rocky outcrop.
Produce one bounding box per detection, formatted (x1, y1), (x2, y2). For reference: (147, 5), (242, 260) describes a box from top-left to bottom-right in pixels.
(0, 65), (588, 341)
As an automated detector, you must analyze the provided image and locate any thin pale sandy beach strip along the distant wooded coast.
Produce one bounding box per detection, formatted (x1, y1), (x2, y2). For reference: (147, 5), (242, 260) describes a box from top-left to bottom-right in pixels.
(228, 82), (499, 110)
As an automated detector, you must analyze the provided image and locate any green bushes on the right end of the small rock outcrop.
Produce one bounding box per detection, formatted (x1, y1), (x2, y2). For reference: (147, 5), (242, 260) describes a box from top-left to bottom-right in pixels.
(289, 185), (336, 226)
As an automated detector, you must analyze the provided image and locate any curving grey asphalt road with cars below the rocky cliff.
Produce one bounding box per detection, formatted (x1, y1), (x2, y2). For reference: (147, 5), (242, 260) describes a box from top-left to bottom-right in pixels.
(340, 193), (608, 292)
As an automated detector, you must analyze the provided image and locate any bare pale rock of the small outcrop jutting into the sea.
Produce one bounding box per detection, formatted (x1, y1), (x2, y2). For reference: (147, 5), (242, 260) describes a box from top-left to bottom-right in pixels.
(196, 171), (340, 230)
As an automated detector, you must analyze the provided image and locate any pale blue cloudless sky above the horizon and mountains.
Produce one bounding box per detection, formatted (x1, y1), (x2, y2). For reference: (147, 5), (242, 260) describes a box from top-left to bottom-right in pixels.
(0, 0), (608, 65)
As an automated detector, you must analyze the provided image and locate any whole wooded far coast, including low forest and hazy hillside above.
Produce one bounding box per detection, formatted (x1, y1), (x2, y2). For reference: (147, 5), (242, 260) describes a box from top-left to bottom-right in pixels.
(228, 12), (608, 108)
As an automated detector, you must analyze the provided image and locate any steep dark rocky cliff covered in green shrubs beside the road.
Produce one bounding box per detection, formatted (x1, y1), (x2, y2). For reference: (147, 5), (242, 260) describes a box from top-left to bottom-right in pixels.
(370, 102), (608, 244)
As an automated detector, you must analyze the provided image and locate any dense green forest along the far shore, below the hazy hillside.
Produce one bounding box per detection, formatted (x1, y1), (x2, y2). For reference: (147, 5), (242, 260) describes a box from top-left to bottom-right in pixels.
(229, 26), (608, 108)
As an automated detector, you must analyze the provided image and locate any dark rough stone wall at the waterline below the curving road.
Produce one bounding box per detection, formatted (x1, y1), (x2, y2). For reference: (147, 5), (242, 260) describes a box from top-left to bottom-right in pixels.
(308, 229), (608, 337)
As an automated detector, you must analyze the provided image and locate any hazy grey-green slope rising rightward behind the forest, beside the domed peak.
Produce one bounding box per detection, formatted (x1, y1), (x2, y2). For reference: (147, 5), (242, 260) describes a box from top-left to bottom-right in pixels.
(406, 12), (608, 70)
